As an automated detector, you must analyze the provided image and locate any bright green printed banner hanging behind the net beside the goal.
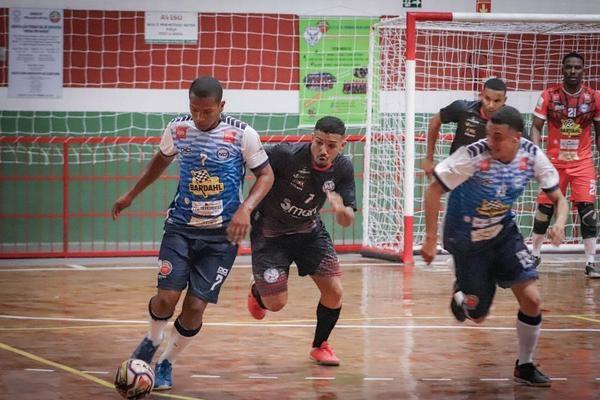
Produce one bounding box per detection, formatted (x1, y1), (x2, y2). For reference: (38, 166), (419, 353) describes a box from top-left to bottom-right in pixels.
(299, 17), (378, 126)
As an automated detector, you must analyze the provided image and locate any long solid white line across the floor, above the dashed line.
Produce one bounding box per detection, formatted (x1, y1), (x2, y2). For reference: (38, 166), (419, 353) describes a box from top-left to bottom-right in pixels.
(0, 314), (600, 332)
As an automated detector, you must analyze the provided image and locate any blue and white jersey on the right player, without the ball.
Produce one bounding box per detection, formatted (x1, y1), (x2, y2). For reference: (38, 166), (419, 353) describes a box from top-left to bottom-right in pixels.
(434, 138), (558, 243)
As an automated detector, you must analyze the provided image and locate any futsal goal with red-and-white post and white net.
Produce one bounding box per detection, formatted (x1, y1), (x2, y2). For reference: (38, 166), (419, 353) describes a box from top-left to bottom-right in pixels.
(363, 13), (600, 262)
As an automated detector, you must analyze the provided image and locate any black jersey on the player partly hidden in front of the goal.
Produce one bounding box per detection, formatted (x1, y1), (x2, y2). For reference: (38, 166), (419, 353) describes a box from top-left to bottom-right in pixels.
(440, 100), (488, 154)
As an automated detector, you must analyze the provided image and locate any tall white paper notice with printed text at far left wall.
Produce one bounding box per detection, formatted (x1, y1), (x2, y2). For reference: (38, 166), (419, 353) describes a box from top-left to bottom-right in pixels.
(8, 8), (64, 98)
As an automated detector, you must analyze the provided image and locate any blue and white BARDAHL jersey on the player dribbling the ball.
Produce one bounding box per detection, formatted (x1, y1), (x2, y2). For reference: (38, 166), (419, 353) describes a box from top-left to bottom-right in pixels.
(160, 114), (268, 229)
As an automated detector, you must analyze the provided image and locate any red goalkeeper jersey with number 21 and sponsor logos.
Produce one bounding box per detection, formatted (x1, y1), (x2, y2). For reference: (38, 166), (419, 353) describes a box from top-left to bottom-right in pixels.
(533, 84), (600, 166)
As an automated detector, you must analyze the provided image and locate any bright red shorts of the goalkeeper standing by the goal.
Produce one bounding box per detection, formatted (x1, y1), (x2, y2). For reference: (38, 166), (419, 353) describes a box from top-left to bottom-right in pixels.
(537, 159), (596, 204)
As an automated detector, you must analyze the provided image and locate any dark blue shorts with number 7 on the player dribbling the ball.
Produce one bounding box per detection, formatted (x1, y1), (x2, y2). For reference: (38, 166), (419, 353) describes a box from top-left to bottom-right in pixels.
(157, 224), (237, 303)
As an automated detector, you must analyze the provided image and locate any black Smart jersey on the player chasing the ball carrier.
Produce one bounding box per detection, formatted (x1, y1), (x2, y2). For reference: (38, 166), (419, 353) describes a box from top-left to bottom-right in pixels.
(254, 143), (356, 236)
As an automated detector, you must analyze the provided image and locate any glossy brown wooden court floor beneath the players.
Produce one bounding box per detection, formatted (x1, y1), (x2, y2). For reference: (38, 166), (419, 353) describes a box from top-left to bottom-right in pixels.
(0, 255), (600, 400)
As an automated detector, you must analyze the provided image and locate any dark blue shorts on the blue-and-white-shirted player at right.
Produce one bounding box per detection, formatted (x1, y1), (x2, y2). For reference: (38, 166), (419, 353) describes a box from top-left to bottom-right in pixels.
(444, 222), (538, 318)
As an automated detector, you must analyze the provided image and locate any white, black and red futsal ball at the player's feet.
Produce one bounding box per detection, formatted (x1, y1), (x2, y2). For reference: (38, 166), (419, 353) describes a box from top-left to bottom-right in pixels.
(115, 358), (154, 399)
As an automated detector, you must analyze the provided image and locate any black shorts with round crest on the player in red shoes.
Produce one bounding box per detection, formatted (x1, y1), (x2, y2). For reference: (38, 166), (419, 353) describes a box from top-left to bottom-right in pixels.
(250, 222), (342, 296)
